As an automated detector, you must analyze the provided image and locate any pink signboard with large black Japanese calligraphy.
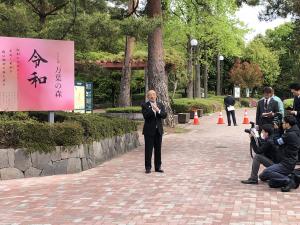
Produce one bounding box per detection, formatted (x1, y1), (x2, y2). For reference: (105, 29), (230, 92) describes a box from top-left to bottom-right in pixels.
(0, 37), (74, 111)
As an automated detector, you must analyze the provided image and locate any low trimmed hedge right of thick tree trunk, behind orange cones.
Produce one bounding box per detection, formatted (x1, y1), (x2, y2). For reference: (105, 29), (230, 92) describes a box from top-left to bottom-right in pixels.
(172, 98), (223, 113)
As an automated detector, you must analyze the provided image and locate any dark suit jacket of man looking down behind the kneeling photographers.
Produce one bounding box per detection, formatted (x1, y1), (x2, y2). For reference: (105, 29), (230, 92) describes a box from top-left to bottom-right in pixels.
(256, 98), (279, 126)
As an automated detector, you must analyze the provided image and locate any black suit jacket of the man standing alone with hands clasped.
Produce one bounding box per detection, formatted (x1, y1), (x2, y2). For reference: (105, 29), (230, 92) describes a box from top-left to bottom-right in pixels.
(142, 102), (167, 136)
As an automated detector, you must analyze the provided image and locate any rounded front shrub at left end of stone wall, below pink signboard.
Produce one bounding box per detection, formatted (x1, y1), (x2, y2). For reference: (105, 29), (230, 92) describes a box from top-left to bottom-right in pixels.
(0, 120), (84, 152)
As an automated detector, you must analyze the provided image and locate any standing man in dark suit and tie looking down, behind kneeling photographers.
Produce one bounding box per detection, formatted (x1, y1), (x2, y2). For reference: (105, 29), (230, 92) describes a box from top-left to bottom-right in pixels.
(256, 87), (279, 130)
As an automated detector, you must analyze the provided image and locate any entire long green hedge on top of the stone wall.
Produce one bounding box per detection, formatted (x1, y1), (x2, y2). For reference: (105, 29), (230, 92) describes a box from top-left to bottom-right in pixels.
(0, 113), (137, 152)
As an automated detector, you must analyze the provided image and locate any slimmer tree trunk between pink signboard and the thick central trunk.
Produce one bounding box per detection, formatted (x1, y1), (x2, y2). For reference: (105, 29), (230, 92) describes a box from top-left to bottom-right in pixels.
(119, 0), (135, 107)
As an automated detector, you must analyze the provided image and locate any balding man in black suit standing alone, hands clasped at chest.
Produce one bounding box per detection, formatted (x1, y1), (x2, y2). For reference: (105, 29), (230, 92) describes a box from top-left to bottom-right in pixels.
(142, 90), (167, 173)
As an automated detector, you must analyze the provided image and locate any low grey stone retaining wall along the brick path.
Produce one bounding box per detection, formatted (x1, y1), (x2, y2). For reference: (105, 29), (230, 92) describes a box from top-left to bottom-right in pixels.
(0, 133), (139, 180)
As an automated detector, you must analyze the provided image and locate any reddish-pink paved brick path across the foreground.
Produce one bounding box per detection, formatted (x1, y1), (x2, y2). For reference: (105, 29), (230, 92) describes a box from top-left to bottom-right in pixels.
(0, 108), (300, 225)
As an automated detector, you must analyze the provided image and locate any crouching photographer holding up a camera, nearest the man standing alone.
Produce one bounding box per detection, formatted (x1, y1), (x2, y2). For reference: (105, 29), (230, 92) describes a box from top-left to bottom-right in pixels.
(241, 124), (278, 184)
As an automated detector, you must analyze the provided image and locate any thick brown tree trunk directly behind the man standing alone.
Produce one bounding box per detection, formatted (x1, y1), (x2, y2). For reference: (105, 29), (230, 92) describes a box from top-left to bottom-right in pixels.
(147, 0), (175, 127)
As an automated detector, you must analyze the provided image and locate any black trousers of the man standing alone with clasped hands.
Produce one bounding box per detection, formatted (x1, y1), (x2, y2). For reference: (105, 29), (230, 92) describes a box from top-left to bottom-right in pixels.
(144, 129), (162, 170)
